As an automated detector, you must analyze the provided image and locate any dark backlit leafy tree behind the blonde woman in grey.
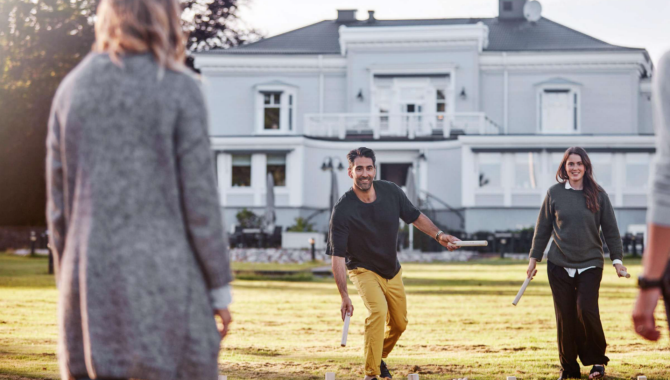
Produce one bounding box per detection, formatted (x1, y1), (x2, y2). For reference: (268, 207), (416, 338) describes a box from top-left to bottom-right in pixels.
(0, 0), (258, 226)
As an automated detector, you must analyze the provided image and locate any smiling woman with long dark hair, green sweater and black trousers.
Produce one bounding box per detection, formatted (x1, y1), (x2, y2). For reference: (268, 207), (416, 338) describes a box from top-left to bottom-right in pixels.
(527, 147), (626, 380)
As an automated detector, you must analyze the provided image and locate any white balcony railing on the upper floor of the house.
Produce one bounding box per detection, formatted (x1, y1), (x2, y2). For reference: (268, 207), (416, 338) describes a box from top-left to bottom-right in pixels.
(304, 112), (502, 139)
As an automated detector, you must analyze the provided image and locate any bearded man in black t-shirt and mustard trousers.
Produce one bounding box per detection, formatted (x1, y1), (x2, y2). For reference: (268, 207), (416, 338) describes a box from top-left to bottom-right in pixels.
(328, 148), (459, 380)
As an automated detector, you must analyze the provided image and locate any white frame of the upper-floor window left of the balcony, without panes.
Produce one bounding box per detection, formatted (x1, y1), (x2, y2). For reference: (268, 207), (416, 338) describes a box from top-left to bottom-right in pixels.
(255, 84), (298, 135)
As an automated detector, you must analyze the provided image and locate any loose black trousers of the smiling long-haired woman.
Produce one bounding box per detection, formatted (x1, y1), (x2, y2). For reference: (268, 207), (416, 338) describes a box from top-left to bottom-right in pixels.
(547, 261), (609, 376)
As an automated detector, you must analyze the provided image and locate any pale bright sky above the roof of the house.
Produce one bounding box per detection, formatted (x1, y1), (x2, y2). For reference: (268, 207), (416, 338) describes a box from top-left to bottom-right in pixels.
(240, 0), (670, 64)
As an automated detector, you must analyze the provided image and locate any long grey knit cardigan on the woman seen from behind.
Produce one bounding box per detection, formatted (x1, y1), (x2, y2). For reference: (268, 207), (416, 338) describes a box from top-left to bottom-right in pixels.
(47, 53), (231, 380)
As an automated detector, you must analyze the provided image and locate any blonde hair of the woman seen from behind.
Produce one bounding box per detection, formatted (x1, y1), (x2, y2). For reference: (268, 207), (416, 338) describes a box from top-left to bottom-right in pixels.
(94, 0), (186, 70)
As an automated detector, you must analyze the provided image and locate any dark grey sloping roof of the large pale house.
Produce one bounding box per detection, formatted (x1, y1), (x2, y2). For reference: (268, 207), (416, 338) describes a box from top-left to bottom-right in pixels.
(201, 18), (645, 54)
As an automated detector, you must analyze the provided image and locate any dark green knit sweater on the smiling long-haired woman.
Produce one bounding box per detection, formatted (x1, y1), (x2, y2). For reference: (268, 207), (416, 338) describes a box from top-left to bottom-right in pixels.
(530, 183), (623, 269)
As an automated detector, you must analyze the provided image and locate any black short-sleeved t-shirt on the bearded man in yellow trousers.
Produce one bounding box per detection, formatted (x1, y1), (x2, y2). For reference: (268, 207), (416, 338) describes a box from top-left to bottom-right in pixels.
(328, 181), (421, 279)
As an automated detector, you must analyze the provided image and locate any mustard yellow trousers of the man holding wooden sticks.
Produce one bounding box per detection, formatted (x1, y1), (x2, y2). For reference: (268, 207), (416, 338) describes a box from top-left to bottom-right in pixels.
(348, 268), (407, 376)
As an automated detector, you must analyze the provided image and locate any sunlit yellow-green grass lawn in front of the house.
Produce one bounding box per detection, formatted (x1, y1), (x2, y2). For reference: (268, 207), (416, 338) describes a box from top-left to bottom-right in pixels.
(0, 254), (670, 380)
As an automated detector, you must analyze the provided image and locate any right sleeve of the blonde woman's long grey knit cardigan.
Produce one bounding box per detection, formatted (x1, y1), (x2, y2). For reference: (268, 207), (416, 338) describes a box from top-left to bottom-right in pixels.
(175, 77), (232, 290)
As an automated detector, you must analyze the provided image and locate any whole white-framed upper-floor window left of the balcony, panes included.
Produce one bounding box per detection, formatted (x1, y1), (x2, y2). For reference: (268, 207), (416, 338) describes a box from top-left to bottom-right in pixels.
(255, 81), (297, 134)
